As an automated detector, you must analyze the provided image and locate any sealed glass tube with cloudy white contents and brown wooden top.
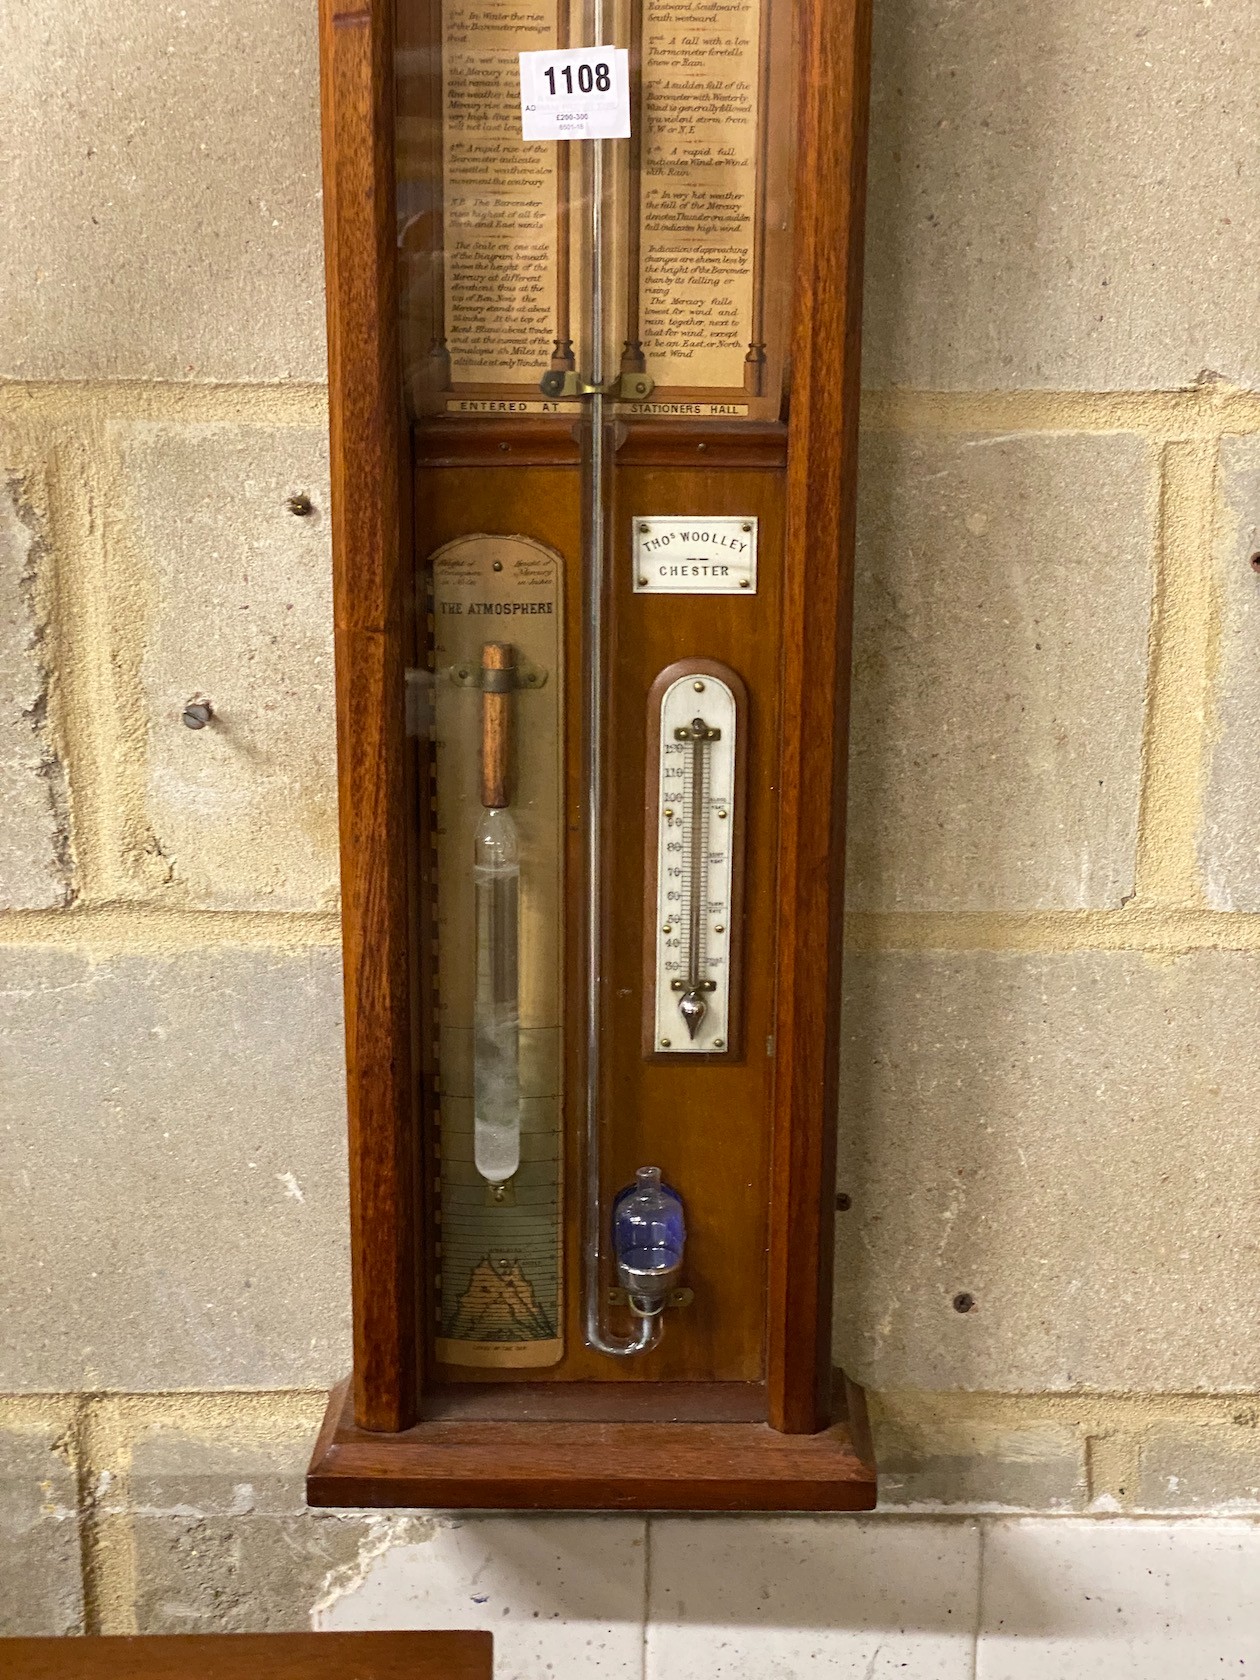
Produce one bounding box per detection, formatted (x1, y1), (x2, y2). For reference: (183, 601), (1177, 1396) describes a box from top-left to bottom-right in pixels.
(472, 642), (521, 1194)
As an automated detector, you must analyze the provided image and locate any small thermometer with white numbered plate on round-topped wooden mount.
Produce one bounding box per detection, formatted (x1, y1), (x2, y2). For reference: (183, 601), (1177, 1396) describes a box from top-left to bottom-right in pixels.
(643, 659), (748, 1057)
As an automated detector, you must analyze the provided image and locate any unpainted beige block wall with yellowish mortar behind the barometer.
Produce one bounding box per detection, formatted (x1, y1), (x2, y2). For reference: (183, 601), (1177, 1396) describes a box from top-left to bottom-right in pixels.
(0, 0), (1260, 1639)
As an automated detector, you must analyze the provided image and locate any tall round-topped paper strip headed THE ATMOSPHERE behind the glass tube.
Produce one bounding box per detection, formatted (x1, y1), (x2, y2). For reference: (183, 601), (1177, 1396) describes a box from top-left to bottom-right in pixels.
(432, 536), (564, 1368)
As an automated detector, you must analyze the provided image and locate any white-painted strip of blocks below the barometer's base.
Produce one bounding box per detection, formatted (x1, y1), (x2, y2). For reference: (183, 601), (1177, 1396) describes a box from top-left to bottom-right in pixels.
(314, 1515), (1260, 1680)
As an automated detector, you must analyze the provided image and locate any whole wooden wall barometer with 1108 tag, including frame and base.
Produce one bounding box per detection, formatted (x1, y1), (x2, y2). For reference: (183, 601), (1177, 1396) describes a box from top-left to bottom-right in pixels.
(309, 0), (875, 1510)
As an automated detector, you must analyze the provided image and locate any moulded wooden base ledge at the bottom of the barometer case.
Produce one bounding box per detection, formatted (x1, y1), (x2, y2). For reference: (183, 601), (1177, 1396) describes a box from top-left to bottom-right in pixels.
(306, 1384), (875, 1512)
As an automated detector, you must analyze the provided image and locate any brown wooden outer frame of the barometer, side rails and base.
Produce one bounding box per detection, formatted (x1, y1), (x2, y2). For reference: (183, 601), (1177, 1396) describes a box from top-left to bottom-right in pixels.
(307, 0), (875, 1510)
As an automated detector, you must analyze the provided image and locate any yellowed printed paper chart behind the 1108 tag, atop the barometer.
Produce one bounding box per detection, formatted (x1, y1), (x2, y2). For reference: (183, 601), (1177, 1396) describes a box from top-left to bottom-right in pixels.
(398, 0), (793, 420)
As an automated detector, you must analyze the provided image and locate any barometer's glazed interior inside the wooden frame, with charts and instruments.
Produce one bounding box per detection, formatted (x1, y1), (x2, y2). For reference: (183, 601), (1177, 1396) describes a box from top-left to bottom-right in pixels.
(398, 0), (793, 1384)
